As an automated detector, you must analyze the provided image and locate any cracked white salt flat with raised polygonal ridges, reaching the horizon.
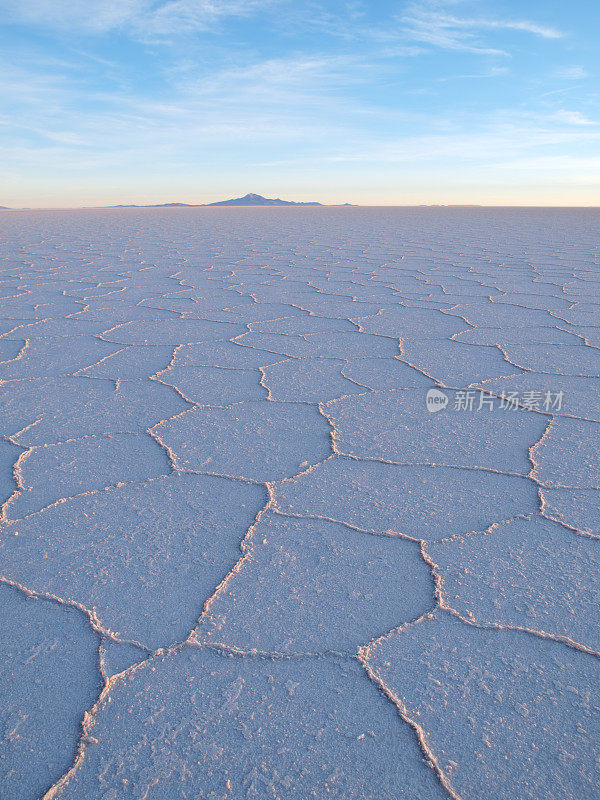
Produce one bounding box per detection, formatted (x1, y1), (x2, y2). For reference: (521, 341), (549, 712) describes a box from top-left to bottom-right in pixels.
(0, 207), (600, 800)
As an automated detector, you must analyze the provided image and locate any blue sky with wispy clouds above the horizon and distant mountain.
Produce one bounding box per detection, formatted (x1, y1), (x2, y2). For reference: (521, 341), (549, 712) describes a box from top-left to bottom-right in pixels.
(0, 0), (600, 207)
